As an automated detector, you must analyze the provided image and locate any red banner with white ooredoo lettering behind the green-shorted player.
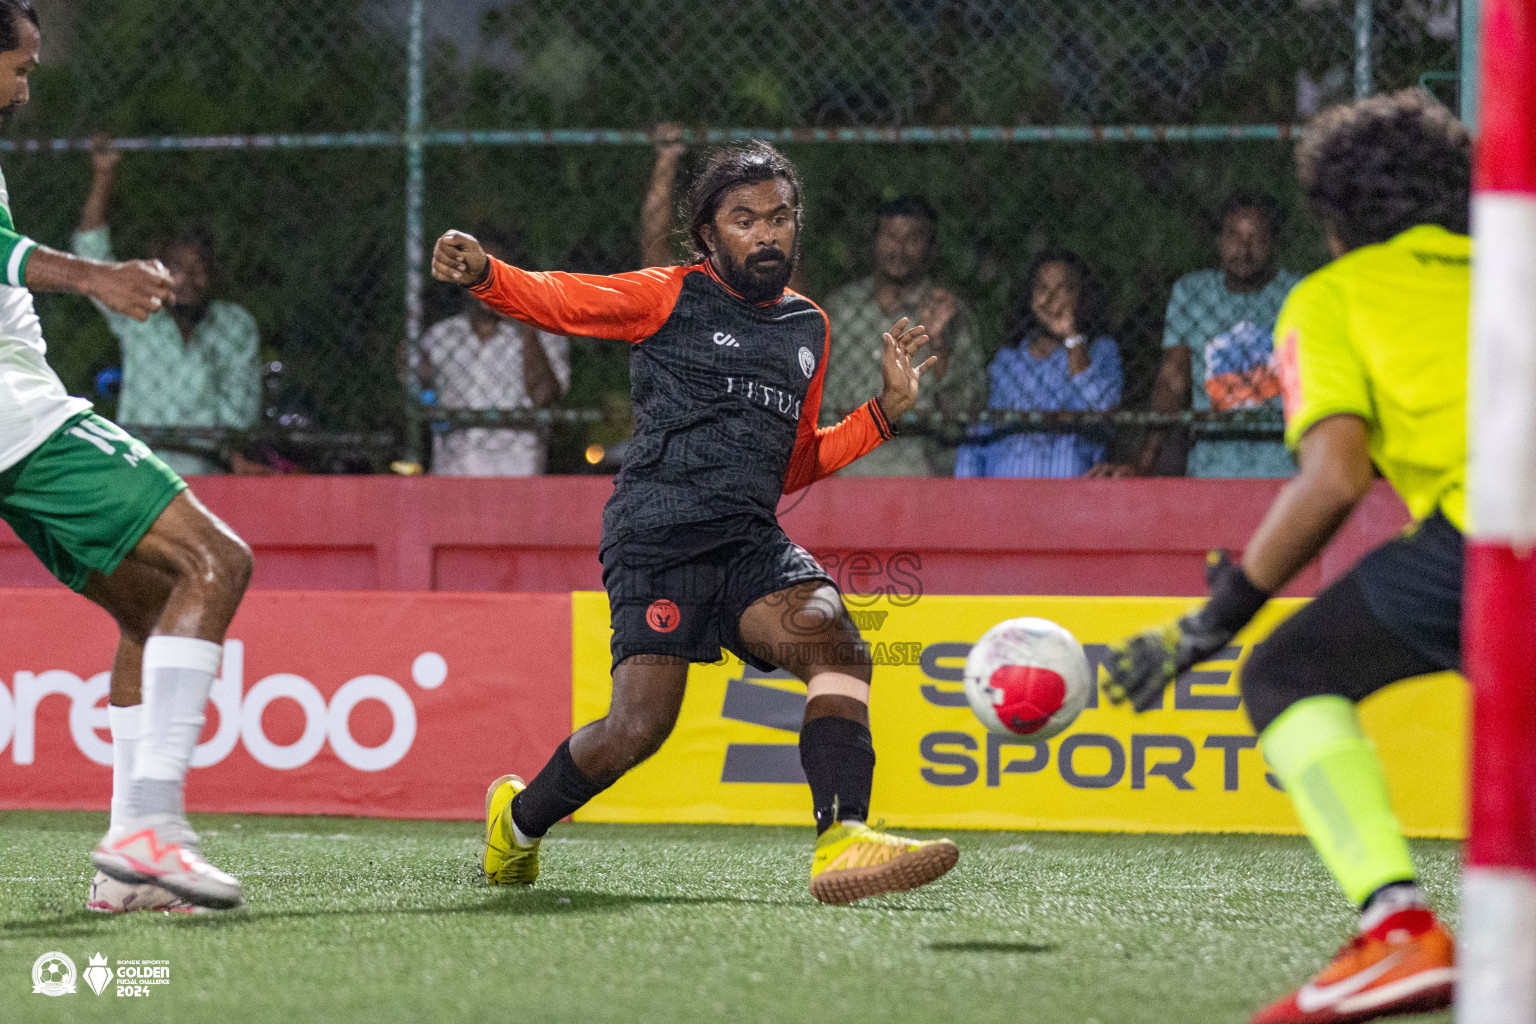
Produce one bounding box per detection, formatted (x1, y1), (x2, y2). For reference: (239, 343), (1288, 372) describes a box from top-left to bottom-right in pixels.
(0, 590), (571, 818)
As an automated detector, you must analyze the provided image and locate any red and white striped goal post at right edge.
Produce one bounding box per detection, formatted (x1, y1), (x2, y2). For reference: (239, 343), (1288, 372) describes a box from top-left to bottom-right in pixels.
(1456, 0), (1536, 1024)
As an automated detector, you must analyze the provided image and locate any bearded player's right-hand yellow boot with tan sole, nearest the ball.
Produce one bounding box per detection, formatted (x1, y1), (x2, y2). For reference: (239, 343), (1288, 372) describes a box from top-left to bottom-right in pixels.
(811, 824), (960, 903)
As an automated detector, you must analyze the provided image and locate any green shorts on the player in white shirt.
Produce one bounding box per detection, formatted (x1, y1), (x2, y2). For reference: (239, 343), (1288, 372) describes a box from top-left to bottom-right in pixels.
(0, 413), (186, 591)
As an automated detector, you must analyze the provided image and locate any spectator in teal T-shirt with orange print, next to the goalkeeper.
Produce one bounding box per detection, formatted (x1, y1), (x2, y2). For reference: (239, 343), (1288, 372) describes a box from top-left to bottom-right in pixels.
(1101, 192), (1301, 477)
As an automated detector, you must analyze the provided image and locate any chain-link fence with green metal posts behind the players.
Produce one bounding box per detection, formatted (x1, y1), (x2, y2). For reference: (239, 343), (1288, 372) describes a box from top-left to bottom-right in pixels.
(0, 0), (1459, 473)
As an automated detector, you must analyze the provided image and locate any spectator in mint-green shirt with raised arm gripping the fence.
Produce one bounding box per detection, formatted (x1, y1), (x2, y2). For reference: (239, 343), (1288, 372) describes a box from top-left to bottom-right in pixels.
(69, 140), (261, 476)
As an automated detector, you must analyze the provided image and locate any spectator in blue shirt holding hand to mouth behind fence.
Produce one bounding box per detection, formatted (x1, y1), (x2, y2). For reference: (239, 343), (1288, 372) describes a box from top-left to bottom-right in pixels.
(955, 249), (1124, 477)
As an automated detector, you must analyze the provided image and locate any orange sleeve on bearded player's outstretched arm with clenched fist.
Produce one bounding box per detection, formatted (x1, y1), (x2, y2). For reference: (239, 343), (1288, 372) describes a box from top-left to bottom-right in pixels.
(470, 256), (690, 341)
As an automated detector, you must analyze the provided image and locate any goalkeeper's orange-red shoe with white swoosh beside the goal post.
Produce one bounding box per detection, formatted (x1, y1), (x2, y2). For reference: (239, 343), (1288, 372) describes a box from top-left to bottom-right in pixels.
(1253, 907), (1456, 1024)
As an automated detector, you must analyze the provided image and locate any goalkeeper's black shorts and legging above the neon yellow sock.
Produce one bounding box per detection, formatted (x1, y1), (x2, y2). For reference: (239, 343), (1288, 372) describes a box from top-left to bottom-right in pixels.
(1241, 513), (1464, 732)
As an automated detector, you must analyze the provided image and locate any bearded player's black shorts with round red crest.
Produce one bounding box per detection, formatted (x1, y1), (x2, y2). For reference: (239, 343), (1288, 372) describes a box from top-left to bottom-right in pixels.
(601, 516), (833, 671)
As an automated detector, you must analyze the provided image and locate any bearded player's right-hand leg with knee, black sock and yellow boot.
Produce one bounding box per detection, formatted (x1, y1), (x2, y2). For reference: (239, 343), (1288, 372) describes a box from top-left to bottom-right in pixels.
(740, 580), (960, 903)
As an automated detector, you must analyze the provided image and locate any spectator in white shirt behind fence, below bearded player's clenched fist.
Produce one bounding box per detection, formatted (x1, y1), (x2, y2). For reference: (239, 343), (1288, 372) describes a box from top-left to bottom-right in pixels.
(421, 229), (571, 476)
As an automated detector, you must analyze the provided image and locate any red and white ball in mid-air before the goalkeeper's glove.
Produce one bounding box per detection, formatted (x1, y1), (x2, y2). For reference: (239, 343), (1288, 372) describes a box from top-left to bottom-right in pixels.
(965, 619), (1094, 740)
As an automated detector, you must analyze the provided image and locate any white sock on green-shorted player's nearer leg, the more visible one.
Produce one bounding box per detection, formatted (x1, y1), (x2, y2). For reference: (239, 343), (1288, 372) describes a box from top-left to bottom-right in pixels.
(134, 636), (224, 786)
